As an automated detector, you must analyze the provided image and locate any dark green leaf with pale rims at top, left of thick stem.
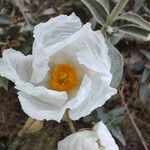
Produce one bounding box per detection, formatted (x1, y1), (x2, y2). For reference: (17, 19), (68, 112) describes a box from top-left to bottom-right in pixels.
(81, 0), (109, 25)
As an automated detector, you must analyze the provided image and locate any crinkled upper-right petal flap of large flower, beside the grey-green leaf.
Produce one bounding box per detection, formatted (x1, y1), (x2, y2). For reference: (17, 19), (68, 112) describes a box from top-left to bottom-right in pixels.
(77, 31), (112, 84)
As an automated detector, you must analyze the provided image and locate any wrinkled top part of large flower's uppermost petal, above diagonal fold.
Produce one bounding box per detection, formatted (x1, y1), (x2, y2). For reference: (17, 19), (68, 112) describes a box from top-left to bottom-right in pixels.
(33, 13), (82, 47)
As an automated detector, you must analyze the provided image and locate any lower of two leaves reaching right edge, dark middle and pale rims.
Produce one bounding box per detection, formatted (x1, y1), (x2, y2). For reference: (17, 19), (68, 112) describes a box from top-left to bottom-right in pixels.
(114, 24), (150, 41)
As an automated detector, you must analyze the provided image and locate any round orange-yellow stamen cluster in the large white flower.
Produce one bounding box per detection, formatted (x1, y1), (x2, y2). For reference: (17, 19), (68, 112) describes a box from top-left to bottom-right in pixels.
(49, 64), (77, 91)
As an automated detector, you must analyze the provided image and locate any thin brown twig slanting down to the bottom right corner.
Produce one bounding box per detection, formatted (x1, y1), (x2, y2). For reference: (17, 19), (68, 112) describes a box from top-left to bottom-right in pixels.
(119, 88), (148, 150)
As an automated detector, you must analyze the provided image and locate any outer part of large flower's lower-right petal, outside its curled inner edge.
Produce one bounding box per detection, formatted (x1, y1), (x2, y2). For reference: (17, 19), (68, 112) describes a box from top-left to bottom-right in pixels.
(69, 73), (117, 120)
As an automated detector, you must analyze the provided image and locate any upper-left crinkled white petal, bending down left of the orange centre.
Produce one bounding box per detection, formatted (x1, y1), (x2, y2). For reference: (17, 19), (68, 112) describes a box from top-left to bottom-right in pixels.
(32, 13), (82, 83)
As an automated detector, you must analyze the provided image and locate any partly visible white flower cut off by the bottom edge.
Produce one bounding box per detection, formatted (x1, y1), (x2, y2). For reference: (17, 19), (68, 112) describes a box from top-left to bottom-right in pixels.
(58, 122), (119, 150)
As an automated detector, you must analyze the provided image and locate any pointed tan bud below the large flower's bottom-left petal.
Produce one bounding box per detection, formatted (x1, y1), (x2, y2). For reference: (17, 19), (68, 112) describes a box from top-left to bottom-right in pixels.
(18, 118), (43, 136)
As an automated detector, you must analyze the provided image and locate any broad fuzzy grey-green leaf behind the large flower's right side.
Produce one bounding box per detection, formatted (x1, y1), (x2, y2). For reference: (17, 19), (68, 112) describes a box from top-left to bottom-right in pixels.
(107, 41), (124, 88)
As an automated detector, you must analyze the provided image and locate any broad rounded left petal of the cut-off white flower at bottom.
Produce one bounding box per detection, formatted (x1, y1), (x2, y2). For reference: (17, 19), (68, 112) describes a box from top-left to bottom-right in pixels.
(58, 131), (99, 150)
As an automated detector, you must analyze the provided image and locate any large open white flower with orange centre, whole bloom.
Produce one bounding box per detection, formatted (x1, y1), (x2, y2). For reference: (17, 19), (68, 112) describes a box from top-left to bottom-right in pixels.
(0, 14), (117, 121)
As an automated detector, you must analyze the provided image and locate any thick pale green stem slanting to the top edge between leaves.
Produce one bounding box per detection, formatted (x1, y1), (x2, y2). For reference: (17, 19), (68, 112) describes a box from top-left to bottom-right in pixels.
(107, 0), (129, 26)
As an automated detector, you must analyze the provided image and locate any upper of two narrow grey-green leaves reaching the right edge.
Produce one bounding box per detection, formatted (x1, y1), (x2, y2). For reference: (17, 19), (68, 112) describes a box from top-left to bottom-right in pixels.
(117, 12), (150, 31)
